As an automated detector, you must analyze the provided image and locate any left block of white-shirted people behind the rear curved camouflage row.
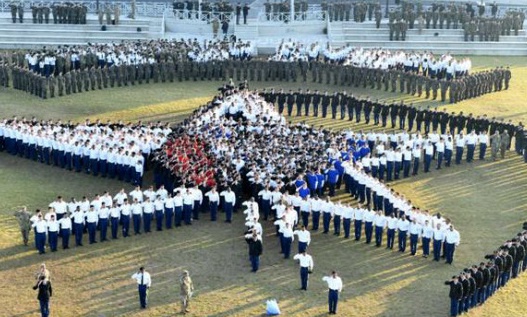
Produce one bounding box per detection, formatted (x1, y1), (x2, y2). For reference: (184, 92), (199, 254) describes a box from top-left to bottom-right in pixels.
(10, 38), (256, 77)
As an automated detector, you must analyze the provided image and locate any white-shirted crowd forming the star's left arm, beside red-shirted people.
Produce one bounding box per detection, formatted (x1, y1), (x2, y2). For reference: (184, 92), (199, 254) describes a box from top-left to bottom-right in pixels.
(0, 117), (171, 185)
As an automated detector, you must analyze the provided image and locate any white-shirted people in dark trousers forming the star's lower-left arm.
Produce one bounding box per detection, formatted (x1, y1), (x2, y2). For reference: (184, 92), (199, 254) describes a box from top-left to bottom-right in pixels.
(26, 186), (236, 254)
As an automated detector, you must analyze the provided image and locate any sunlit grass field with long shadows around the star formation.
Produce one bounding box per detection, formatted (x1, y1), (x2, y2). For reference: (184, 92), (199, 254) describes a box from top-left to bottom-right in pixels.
(0, 57), (527, 317)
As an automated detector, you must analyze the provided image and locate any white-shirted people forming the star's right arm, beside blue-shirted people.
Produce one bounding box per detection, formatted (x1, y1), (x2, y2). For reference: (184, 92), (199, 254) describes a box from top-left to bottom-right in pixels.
(338, 126), (496, 181)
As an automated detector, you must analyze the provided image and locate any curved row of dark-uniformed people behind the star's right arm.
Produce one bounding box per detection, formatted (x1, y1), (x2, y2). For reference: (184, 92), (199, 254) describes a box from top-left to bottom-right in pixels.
(260, 89), (527, 163)
